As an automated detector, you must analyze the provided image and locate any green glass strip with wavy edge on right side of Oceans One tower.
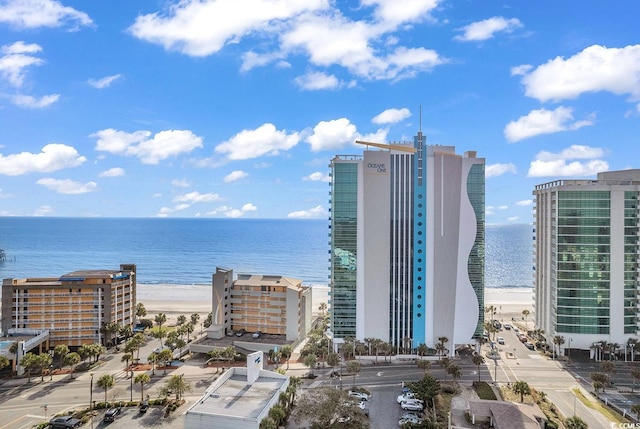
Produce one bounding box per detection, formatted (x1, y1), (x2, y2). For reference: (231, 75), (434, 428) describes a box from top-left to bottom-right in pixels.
(467, 164), (485, 338)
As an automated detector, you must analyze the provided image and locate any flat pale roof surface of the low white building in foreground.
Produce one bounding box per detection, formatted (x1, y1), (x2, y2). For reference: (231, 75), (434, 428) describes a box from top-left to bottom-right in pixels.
(188, 368), (288, 419)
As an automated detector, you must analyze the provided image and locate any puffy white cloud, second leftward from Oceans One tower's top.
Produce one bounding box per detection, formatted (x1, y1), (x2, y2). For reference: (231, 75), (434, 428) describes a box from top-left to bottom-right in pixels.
(215, 123), (300, 160)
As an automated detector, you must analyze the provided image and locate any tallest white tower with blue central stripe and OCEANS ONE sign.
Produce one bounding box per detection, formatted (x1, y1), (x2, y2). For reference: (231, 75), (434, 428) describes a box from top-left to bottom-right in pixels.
(329, 132), (485, 354)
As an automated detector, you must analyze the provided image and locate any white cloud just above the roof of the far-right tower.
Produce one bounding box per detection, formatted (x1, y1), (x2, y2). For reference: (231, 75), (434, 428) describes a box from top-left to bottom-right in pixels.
(527, 145), (609, 177)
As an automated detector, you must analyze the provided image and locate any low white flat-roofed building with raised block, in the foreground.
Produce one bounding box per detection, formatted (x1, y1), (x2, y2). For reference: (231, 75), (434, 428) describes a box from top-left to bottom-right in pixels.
(184, 352), (289, 429)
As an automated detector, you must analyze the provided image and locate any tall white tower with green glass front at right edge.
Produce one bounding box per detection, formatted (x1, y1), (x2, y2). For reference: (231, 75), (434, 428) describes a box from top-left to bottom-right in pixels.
(533, 170), (640, 359)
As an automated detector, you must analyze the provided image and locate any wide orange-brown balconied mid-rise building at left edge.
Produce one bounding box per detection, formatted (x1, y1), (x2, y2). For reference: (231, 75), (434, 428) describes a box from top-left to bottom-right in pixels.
(2, 264), (136, 347)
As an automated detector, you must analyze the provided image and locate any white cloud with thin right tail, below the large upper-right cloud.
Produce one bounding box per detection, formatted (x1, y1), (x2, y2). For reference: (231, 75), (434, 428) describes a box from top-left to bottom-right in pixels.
(504, 106), (593, 143)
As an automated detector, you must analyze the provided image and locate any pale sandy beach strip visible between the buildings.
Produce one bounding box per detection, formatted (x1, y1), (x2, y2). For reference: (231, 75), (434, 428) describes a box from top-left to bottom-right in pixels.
(137, 284), (533, 323)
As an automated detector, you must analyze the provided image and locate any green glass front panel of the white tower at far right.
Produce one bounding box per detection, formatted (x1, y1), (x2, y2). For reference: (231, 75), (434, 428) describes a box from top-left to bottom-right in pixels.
(553, 191), (611, 334)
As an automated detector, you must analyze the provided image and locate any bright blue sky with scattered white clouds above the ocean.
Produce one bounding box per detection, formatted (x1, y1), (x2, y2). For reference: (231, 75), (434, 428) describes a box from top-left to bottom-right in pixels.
(0, 0), (640, 223)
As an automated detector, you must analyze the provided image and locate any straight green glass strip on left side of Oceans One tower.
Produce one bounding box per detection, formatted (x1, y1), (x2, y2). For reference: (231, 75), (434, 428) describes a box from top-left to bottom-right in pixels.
(330, 160), (359, 338)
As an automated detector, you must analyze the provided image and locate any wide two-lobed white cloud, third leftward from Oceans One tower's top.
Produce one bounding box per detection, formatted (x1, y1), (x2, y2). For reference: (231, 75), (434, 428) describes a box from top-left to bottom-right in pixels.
(90, 128), (202, 164)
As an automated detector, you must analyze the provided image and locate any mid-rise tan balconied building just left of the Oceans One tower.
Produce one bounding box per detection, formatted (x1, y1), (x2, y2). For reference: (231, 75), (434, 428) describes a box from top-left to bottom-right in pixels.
(209, 267), (312, 341)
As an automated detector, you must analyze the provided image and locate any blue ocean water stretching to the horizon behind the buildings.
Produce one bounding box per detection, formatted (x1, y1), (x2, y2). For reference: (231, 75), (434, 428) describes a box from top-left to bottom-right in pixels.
(0, 217), (532, 287)
